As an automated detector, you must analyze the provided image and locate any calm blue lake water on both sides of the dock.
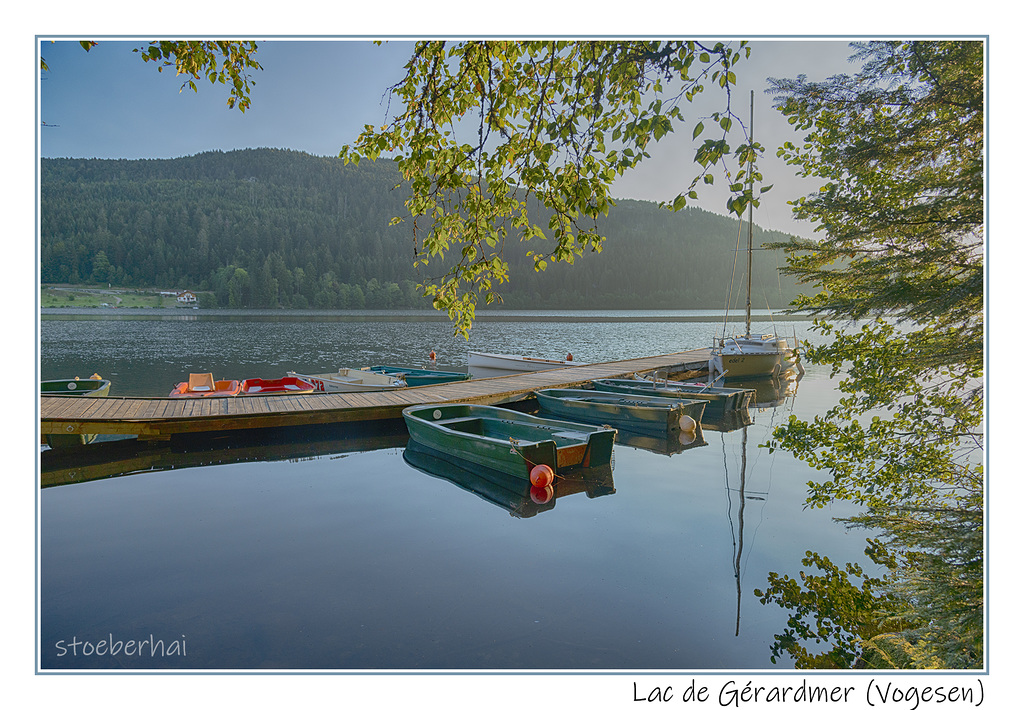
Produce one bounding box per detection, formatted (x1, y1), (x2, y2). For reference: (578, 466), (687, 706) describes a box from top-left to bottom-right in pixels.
(39, 311), (866, 670)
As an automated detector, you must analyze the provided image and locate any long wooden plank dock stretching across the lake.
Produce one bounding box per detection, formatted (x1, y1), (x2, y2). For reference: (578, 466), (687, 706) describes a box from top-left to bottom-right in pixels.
(40, 348), (709, 441)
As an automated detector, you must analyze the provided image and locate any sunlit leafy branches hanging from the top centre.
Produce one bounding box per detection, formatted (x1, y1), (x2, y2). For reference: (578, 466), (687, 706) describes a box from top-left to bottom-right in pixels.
(341, 41), (763, 336)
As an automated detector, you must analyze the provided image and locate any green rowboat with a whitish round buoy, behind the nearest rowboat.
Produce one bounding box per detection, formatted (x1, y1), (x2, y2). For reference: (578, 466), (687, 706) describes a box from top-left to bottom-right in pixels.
(535, 389), (708, 436)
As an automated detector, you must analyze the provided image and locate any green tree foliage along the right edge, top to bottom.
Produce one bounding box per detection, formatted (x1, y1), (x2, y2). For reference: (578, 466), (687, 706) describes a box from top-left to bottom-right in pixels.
(765, 42), (984, 668)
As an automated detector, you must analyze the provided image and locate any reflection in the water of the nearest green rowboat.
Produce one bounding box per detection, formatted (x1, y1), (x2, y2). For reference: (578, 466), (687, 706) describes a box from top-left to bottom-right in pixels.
(403, 440), (615, 517)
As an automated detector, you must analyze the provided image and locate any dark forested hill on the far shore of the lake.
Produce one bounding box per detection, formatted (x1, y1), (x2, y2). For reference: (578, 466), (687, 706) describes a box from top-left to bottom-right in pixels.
(40, 149), (797, 308)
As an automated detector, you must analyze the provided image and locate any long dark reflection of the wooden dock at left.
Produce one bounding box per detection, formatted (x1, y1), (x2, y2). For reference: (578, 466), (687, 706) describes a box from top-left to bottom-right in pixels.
(39, 421), (409, 488)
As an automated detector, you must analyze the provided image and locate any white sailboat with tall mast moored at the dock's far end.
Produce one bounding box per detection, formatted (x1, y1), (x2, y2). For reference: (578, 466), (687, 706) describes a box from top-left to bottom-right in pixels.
(708, 91), (798, 378)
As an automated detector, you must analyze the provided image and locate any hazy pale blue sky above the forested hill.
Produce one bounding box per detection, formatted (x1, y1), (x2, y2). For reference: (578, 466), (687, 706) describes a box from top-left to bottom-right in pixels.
(40, 38), (855, 234)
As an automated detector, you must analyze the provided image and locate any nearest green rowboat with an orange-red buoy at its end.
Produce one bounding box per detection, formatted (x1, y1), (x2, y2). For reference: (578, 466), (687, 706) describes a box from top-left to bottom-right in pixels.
(401, 404), (615, 479)
